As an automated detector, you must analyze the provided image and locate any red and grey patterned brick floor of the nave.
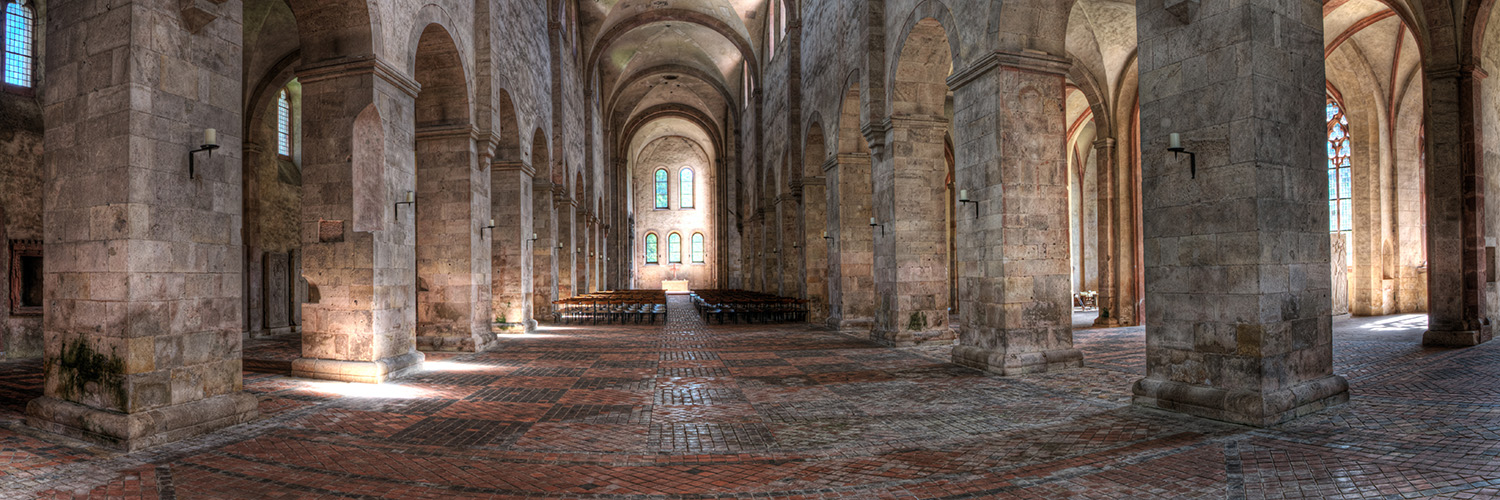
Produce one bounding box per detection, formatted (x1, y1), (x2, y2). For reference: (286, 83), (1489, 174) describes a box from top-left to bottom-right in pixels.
(0, 299), (1500, 498)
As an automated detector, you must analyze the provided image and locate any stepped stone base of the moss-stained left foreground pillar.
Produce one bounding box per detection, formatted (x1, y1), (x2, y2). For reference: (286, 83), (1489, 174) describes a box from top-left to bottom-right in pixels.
(26, 392), (260, 452)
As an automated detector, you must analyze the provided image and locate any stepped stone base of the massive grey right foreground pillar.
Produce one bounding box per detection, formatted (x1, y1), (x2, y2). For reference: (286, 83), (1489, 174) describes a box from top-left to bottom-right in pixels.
(1133, 375), (1349, 426)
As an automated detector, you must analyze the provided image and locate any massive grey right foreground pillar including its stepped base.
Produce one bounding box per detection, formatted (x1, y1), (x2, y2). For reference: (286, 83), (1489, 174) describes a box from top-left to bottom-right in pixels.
(1134, 0), (1349, 426)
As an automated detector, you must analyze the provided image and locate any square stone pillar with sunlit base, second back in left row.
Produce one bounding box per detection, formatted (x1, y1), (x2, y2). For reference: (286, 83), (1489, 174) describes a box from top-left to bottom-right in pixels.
(293, 59), (423, 383)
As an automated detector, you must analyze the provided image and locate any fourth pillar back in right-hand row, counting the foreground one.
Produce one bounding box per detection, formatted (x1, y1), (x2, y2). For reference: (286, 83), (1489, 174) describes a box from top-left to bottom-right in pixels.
(825, 153), (875, 328)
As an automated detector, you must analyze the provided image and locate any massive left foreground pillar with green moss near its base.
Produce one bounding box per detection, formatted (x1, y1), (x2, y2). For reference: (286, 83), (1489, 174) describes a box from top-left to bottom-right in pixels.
(27, 0), (258, 450)
